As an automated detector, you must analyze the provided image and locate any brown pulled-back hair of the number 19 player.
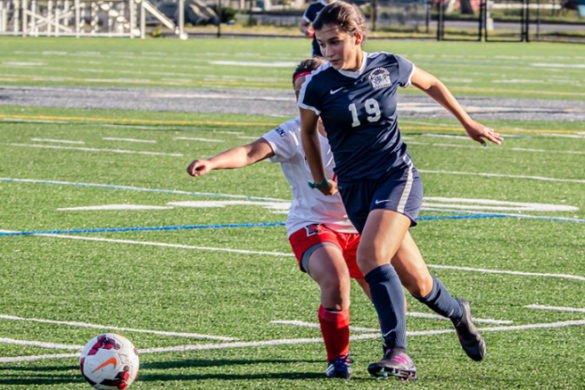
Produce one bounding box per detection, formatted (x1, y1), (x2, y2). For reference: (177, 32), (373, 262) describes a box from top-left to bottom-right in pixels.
(313, 1), (366, 41)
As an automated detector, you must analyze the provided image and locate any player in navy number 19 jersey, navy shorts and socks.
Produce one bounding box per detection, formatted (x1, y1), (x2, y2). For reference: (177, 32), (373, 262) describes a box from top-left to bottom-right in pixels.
(298, 1), (502, 379)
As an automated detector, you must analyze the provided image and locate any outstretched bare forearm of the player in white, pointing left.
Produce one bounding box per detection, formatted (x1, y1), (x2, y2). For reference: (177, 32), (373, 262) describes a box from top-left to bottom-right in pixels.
(187, 138), (274, 177)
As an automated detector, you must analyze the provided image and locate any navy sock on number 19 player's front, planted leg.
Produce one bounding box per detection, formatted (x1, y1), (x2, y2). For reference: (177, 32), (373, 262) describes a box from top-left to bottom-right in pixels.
(365, 264), (406, 348)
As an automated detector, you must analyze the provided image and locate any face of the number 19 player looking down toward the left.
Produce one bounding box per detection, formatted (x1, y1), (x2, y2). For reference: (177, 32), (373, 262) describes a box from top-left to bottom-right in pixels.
(315, 24), (362, 71)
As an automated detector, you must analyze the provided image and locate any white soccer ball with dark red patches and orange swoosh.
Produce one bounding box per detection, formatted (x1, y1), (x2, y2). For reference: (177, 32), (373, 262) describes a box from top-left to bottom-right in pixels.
(79, 333), (139, 390)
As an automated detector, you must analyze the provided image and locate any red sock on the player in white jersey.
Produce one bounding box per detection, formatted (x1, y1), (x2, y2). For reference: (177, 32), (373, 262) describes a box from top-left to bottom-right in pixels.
(319, 306), (349, 362)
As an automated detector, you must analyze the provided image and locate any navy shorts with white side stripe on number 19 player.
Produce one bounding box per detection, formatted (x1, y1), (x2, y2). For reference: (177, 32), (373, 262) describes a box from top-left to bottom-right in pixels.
(339, 161), (423, 233)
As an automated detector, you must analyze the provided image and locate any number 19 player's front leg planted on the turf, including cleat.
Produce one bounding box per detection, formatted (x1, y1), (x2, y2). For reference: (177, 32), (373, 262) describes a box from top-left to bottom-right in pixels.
(358, 209), (416, 379)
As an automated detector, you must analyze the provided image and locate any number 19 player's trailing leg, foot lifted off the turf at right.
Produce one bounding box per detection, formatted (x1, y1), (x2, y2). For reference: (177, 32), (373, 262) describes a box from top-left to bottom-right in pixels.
(392, 233), (486, 361)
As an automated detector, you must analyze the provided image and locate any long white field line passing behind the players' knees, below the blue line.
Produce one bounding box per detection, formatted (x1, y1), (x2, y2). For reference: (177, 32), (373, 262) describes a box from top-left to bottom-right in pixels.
(0, 230), (585, 282)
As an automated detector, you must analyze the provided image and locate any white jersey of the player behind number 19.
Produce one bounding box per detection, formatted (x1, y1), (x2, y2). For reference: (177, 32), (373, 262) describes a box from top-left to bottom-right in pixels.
(262, 117), (357, 236)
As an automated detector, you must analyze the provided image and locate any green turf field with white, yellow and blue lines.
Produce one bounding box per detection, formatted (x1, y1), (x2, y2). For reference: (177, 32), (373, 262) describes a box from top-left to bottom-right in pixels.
(0, 38), (585, 389)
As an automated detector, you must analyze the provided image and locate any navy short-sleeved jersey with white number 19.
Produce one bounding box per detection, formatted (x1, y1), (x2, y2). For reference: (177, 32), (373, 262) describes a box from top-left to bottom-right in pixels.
(299, 52), (414, 183)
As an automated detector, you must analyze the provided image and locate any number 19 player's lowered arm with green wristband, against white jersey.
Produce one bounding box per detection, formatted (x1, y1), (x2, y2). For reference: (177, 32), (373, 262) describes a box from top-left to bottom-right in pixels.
(299, 108), (337, 195)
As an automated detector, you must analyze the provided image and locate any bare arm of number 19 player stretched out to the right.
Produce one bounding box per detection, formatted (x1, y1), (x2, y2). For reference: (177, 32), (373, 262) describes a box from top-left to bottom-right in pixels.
(411, 67), (503, 145)
